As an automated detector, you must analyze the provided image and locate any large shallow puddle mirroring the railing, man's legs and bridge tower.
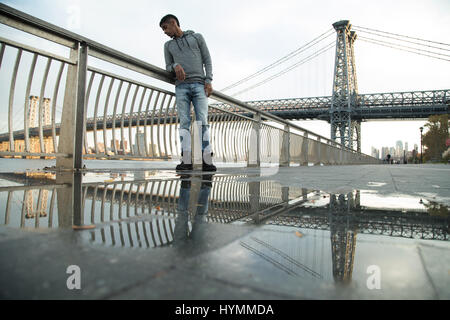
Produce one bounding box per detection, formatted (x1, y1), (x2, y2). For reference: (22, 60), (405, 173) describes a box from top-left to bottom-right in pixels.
(0, 171), (450, 298)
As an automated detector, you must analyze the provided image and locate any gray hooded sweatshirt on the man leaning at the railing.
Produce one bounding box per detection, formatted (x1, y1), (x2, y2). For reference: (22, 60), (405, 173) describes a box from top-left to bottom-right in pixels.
(164, 30), (212, 85)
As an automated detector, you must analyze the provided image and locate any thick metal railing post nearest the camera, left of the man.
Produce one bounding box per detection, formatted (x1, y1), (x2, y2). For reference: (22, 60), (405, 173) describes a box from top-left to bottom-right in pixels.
(56, 43), (88, 170)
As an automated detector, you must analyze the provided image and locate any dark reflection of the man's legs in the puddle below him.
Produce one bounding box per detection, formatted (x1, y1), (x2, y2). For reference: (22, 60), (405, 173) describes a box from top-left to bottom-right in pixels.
(173, 175), (212, 243)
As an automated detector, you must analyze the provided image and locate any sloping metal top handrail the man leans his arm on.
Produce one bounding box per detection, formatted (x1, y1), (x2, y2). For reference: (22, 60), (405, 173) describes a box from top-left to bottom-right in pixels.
(0, 3), (380, 157)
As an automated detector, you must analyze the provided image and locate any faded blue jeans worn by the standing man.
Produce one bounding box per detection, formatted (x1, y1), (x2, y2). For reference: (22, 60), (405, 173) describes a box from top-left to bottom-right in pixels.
(175, 83), (211, 154)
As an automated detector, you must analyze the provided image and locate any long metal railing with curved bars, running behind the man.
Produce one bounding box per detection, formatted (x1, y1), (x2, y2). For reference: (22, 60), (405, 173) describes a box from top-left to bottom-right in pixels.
(0, 4), (379, 170)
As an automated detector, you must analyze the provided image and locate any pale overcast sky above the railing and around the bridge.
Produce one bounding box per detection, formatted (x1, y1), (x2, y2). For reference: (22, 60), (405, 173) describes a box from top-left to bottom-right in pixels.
(0, 0), (450, 154)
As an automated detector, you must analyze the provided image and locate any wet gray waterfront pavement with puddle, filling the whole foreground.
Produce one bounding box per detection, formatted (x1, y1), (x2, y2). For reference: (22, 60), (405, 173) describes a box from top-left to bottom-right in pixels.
(0, 159), (450, 300)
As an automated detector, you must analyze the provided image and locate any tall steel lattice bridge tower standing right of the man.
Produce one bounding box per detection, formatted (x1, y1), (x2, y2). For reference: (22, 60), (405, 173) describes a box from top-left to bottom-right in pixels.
(330, 20), (361, 152)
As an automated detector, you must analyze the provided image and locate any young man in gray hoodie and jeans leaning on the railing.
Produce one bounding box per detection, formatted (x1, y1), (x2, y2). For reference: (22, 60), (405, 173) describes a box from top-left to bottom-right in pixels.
(159, 14), (216, 171)
